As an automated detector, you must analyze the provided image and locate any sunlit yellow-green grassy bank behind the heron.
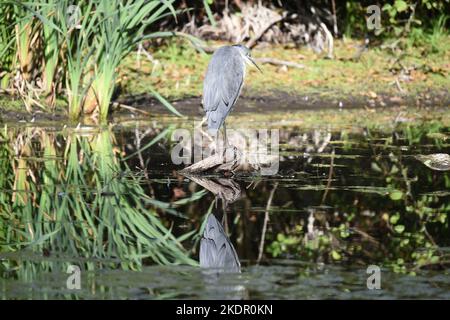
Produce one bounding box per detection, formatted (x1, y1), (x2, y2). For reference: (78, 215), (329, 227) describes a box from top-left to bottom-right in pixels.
(120, 36), (450, 99)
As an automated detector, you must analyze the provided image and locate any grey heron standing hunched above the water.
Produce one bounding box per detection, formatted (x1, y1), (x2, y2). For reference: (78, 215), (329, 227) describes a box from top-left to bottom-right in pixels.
(203, 44), (262, 146)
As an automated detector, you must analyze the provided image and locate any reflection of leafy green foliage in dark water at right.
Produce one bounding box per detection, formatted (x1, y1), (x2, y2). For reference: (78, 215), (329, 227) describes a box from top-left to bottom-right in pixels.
(267, 122), (450, 272)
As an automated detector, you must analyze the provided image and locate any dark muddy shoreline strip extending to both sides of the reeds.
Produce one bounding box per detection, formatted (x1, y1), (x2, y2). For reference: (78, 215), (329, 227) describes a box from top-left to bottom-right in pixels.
(0, 90), (450, 124)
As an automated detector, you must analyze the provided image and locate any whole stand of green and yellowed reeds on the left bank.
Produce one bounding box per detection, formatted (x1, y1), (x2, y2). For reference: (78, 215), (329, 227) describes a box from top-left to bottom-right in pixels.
(0, 0), (185, 120)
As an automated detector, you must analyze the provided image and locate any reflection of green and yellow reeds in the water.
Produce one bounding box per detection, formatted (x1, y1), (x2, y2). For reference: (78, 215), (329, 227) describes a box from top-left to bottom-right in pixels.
(0, 129), (195, 269)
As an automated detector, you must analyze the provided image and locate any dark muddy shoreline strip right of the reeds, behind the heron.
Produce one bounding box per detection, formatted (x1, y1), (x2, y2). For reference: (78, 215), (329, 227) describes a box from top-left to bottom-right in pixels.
(119, 90), (450, 116)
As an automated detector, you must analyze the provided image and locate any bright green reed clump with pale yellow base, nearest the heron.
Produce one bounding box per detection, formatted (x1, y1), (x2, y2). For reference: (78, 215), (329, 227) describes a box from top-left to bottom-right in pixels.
(43, 0), (175, 120)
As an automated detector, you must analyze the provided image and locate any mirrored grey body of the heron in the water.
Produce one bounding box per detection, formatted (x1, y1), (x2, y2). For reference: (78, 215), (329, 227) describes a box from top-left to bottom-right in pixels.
(200, 214), (241, 272)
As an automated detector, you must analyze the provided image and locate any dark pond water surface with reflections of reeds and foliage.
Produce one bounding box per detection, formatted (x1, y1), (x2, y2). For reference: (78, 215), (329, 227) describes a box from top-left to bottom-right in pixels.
(0, 110), (450, 299)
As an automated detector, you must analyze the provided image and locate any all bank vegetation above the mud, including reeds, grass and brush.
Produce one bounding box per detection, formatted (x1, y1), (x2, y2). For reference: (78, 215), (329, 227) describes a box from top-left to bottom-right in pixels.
(0, 0), (450, 120)
